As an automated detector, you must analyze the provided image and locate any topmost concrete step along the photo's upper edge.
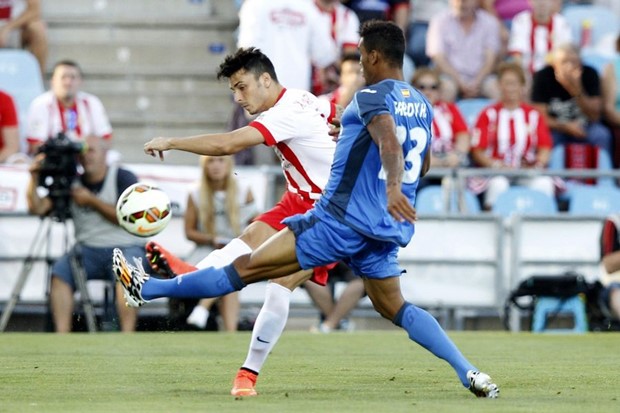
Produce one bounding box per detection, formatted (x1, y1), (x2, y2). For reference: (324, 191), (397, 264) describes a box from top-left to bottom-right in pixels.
(42, 0), (237, 24)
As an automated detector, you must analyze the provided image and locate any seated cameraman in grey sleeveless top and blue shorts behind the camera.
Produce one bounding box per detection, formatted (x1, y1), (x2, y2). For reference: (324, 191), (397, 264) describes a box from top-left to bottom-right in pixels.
(27, 135), (144, 333)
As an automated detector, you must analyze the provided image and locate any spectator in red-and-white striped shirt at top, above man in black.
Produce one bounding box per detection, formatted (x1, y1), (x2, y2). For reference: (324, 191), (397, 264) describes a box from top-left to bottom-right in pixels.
(508, 0), (572, 77)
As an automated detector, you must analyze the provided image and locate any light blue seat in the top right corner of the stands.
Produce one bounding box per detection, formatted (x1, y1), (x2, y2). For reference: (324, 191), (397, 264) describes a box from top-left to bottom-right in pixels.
(562, 4), (620, 47)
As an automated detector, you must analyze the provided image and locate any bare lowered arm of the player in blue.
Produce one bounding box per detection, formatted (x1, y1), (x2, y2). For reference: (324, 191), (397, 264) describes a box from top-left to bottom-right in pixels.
(368, 114), (416, 223)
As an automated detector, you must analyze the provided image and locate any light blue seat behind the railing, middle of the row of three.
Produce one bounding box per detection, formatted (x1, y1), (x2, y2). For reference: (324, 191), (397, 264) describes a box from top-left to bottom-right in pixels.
(492, 186), (558, 218)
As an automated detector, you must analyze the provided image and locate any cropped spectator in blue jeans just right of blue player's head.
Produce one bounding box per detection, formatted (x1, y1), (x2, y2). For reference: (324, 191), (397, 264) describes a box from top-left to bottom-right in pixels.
(406, 0), (449, 67)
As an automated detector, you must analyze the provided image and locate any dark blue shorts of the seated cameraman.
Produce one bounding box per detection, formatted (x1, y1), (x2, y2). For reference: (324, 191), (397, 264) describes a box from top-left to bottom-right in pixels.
(52, 245), (148, 290)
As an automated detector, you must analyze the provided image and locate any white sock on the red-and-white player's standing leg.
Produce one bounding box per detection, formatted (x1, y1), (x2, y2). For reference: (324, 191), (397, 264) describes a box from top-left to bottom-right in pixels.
(243, 282), (291, 373)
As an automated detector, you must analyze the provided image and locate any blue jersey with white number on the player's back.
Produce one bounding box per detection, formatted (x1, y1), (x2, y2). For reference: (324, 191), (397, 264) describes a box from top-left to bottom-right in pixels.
(315, 79), (432, 246)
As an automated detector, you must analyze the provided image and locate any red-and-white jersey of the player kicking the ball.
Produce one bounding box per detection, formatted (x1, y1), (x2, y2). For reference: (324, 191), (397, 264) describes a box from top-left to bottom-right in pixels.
(250, 89), (336, 200)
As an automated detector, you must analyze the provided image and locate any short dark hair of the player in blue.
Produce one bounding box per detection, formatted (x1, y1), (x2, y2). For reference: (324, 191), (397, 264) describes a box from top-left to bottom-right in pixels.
(360, 20), (405, 67)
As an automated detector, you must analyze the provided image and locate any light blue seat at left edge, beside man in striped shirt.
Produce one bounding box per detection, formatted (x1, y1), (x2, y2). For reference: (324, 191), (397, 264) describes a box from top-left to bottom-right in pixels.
(0, 49), (45, 143)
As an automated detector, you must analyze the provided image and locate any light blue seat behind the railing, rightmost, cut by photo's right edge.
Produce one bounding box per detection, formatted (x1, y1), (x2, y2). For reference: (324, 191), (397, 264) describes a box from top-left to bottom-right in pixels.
(568, 185), (620, 217)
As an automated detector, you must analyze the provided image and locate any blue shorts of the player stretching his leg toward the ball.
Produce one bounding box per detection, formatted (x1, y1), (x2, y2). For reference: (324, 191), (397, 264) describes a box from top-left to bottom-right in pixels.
(284, 210), (404, 278)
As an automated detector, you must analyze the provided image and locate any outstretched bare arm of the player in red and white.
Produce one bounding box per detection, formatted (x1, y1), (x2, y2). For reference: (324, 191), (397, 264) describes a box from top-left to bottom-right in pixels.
(144, 126), (264, 160)
